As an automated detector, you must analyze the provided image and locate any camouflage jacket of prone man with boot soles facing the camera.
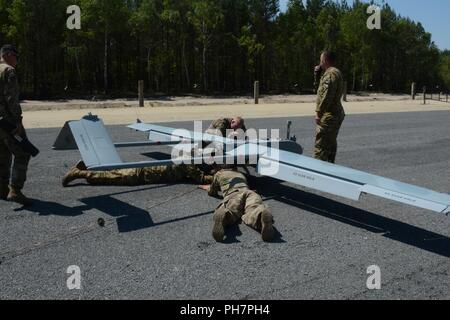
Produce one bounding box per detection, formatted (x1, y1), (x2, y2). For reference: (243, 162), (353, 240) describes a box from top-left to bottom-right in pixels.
(208, 170), (248, 198)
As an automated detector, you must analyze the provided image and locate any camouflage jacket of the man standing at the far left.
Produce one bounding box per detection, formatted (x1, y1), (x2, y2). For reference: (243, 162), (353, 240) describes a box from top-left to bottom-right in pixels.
(0, 62), (22, 123)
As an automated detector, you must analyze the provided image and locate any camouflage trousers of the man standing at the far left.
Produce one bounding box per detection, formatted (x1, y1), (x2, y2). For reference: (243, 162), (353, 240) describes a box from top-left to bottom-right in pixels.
(0, 129), (31, 190)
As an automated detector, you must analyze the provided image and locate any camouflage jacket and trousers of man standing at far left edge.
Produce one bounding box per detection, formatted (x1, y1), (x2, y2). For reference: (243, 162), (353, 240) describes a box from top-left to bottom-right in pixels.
(0, 62), (30, 194)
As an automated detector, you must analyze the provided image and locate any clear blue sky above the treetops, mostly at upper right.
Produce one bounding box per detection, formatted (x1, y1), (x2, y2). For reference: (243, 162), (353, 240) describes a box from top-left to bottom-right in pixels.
(280, 0), (450, 50)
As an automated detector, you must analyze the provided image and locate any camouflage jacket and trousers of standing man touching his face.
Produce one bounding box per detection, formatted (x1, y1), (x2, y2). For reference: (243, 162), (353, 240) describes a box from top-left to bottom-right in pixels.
(314, 67), (345, 163)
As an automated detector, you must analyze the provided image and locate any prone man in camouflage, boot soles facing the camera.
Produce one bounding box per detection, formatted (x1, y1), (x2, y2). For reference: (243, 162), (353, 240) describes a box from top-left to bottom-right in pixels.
(200, 169), (275, 242)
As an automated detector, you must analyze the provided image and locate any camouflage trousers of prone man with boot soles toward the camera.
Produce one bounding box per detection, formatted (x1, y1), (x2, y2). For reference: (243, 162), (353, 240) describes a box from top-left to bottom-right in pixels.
(215, 189), (269, 230)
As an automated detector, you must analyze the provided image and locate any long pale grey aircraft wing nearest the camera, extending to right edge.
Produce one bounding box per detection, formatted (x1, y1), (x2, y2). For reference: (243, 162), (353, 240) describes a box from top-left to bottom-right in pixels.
(253, 149), (450, 214)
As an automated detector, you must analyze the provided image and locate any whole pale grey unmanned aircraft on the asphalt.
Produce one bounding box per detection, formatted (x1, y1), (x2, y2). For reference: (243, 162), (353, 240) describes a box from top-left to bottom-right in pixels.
(53, 114), (450, 215)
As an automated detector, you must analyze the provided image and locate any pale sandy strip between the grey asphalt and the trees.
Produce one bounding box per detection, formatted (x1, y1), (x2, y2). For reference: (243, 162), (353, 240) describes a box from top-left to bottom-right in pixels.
(23, 96), (450, 128)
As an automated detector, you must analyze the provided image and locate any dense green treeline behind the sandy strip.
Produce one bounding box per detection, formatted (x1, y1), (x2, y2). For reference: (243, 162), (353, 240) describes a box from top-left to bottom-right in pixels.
(0, 0), (450, 98)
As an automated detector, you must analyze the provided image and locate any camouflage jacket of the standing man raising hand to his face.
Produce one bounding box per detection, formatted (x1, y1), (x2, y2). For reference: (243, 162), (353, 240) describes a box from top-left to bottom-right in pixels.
(316, 67), (344, 117)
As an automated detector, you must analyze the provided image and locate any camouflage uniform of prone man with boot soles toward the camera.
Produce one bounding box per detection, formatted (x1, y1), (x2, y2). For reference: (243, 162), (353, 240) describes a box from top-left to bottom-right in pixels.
(208, 170), (273, 236)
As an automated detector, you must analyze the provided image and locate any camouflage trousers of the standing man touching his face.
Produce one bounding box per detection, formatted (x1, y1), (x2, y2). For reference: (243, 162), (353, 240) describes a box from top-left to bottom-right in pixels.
(314, 114), (345, 163)
